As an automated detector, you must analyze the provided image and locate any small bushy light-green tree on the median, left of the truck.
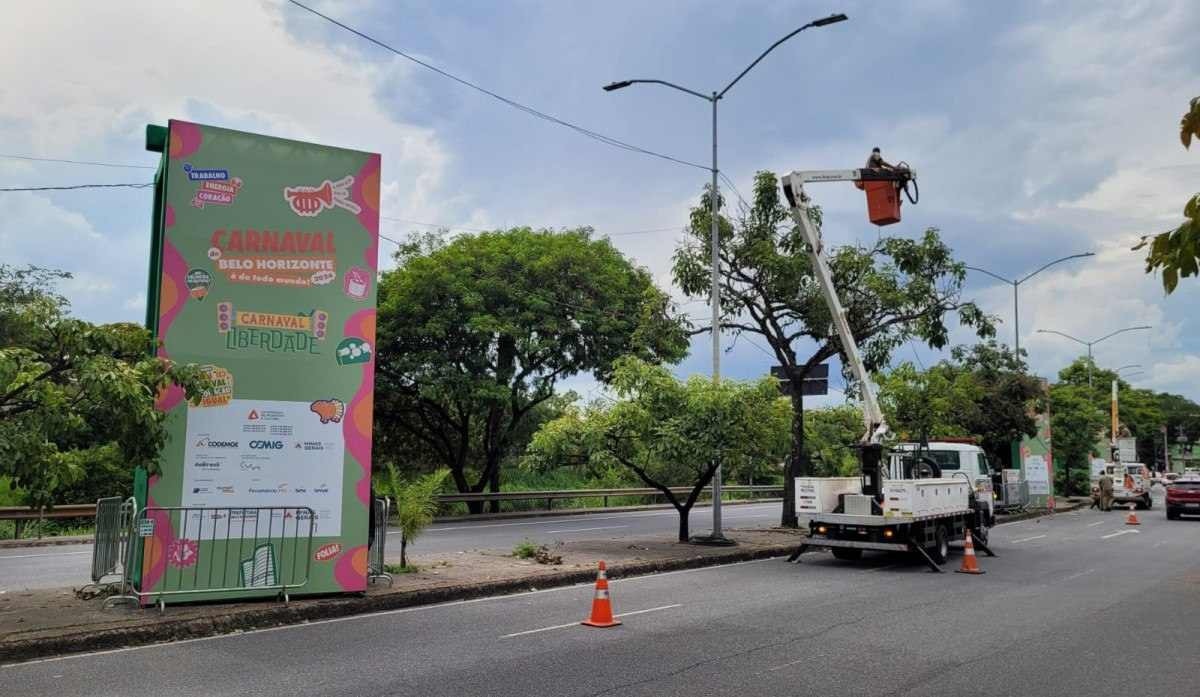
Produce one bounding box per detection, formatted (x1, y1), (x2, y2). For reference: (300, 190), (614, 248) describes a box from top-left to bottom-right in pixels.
(529, 357), (788, 542)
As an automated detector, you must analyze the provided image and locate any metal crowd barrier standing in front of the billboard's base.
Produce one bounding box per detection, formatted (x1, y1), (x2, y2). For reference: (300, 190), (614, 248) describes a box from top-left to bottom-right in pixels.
(133, 506), (316, 609)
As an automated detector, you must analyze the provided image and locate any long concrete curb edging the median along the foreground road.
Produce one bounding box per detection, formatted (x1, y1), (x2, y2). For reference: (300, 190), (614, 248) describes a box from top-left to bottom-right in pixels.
(0, 537), (796, 666)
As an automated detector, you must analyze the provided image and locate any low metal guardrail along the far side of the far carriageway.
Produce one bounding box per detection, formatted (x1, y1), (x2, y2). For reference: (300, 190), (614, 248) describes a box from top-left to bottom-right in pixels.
(11, 483), (784, 535)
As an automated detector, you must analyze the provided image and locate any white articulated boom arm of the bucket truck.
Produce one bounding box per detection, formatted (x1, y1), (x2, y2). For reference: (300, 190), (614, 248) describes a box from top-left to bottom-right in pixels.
(782, 169), (899, 445)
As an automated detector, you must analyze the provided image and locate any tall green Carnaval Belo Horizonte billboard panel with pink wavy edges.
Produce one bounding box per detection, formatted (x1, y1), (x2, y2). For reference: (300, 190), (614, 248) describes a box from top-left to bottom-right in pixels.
(140, 121), (380, 602)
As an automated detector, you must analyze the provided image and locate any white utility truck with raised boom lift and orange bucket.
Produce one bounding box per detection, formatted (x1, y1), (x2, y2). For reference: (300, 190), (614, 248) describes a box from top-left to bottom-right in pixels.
(782, 167), (995, 571)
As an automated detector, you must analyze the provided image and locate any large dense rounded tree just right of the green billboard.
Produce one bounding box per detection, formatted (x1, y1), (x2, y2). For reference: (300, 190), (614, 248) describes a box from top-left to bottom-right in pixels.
(376, 228), (686, 512)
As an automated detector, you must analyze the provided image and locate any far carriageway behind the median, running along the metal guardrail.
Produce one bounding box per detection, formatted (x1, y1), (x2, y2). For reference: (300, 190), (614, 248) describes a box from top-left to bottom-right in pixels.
(0, 503), (781, 591)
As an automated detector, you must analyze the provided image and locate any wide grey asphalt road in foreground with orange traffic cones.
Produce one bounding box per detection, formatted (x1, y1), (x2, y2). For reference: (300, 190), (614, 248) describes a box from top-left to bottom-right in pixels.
(0, 496), (1200, 697)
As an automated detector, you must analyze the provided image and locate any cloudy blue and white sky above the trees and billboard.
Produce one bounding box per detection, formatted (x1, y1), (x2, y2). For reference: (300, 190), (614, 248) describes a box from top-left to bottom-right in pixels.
(0, 0), (1200, 399)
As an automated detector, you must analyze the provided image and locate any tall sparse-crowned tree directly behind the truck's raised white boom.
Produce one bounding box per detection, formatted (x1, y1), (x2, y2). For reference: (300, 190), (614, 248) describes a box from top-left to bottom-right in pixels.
(673, 172), (994, 525)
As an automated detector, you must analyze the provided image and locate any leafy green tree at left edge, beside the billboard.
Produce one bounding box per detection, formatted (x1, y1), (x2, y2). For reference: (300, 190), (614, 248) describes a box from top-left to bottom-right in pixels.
(0, 266), (206, 506)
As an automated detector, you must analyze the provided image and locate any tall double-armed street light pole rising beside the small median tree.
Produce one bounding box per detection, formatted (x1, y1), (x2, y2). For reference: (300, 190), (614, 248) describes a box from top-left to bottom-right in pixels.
(604, 14), (847, 545)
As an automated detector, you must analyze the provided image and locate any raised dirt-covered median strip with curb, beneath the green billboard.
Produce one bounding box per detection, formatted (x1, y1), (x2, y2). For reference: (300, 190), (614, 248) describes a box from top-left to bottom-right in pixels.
(0, 529), (800, 665)
